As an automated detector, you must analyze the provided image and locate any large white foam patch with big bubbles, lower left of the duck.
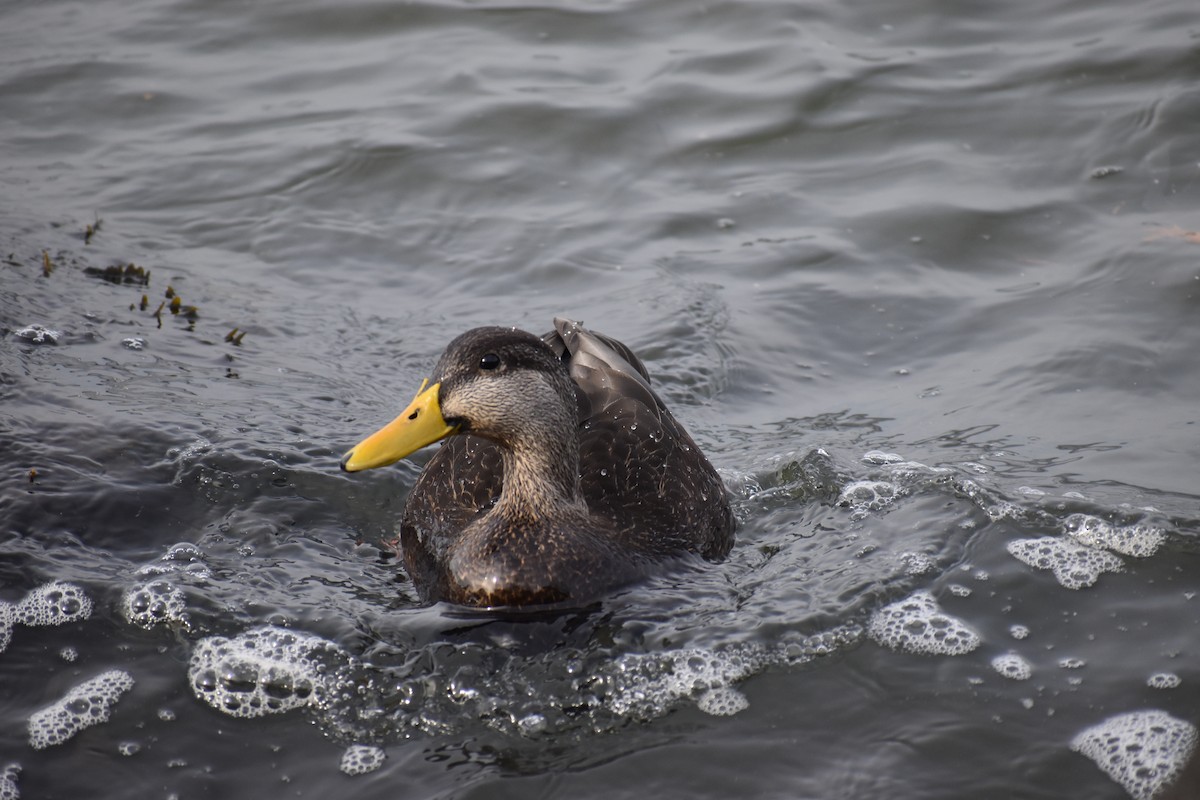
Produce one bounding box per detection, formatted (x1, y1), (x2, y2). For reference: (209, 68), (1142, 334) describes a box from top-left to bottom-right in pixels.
(187, 626), (349, 717)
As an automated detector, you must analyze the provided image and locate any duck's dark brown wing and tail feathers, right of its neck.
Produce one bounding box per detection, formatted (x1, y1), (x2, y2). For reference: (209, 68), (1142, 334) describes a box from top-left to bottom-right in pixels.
(544, 319), (733, 558)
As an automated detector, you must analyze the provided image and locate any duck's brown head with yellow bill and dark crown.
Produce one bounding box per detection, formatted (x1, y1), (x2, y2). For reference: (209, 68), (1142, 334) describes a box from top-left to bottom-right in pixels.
(342, 327), (576, 473)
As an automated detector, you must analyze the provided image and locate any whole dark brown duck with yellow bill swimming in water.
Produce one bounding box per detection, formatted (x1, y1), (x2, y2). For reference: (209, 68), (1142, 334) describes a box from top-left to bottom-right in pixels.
(341, 318), (736, 609)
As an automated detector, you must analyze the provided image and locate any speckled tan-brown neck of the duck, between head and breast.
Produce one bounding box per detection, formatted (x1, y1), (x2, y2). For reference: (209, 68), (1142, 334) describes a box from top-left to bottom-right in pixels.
(496, 429), (587, 522)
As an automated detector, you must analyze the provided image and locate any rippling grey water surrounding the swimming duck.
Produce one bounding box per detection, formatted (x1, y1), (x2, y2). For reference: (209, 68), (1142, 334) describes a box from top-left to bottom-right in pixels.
(0, 0), (1200, 798)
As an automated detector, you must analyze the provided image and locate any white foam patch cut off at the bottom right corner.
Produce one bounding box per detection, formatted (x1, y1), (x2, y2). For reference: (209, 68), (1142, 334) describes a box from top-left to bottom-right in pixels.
(1070, 710), (1196, 800)
